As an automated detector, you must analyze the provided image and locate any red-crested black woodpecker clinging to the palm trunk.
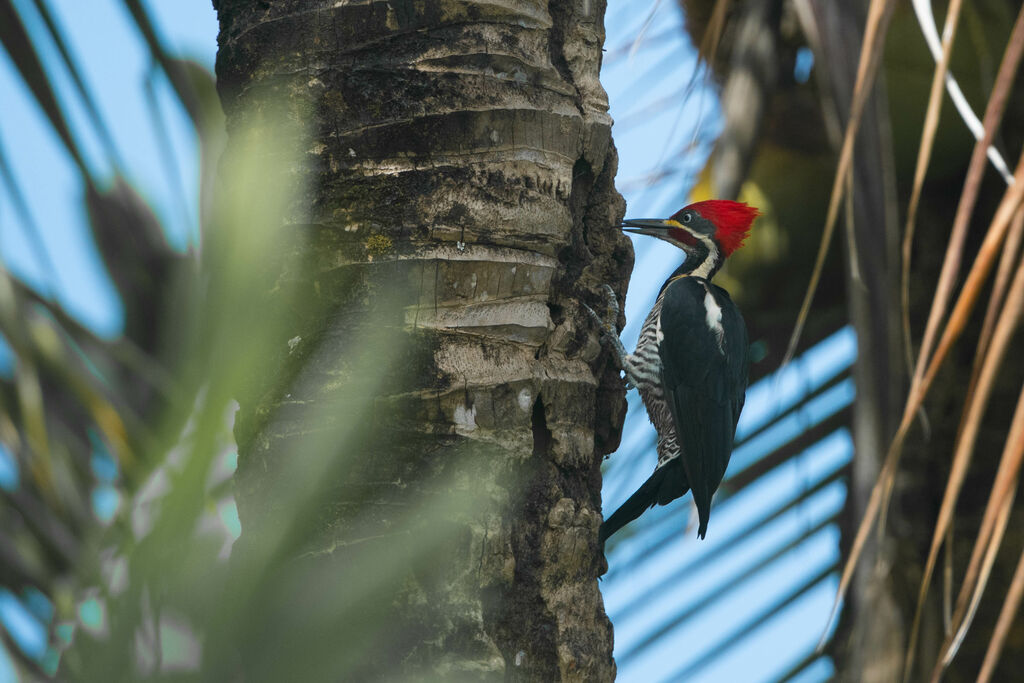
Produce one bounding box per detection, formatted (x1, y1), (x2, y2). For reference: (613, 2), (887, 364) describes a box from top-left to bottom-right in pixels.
(588, 200), (760, 544)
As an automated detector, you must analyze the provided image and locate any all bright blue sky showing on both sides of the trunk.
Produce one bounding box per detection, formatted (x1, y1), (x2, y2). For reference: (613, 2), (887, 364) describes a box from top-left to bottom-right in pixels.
(0, 0), (843, 683)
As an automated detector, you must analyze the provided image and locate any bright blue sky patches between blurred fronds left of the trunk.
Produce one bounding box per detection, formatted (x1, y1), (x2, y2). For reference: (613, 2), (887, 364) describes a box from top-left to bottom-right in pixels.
(0, 0), (217, 336)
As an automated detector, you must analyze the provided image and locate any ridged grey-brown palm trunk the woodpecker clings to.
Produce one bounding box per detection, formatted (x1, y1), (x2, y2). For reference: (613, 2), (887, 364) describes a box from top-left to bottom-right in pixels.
(214, 0), (633, 681)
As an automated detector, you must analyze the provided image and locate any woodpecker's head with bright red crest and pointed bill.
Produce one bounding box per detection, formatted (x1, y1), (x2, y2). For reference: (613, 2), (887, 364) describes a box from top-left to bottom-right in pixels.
(623, 200), (761, 280)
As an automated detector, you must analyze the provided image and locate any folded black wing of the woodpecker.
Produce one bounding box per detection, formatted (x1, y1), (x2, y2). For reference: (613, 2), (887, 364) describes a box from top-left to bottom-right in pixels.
(658, 278), (749, 538)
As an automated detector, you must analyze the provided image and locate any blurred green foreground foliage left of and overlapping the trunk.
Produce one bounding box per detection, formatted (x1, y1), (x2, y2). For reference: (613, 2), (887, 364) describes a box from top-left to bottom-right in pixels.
(0, 0), (491, 681)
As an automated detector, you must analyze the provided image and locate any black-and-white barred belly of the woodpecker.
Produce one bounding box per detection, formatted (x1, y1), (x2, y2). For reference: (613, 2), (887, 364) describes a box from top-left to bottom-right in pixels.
(625, 293), (679, 467)
